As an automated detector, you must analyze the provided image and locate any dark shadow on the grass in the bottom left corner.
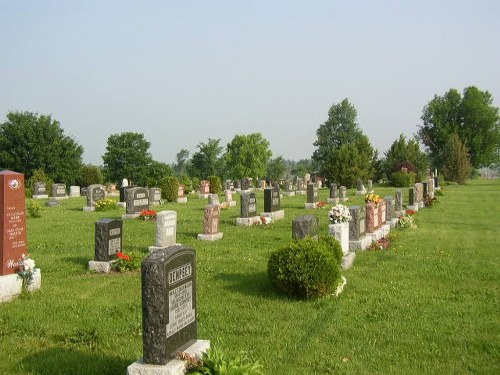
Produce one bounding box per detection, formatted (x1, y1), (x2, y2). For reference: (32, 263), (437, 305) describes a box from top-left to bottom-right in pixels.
(19, 347), (132, 375)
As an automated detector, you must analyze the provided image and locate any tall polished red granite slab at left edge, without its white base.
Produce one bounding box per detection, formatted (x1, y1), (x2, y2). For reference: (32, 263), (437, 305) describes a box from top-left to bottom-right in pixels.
(0, 171), (28, 276)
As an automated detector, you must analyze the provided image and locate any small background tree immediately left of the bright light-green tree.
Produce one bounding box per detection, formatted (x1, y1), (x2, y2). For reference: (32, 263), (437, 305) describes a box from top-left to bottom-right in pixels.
(188, 138), (223, 179)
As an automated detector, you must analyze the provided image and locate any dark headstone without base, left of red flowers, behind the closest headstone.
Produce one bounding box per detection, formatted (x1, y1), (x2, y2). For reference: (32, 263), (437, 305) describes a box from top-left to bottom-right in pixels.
(94, 219), (123, 262)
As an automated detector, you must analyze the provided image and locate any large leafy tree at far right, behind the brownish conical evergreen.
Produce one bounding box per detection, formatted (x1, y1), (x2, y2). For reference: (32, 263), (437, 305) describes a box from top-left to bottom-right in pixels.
(418, 86), (500, 168)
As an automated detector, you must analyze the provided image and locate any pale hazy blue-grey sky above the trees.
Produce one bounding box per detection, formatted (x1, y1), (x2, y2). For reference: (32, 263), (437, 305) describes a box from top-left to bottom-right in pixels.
(0, 0), (500, 165)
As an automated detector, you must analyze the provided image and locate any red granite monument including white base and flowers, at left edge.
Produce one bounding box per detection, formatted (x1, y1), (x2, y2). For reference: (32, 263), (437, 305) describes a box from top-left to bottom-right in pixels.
(0, 171), (41, 303)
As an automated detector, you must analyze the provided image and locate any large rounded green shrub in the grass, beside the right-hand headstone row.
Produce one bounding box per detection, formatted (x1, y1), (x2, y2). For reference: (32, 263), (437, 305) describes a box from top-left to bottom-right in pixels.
(267, 237), (342, 299)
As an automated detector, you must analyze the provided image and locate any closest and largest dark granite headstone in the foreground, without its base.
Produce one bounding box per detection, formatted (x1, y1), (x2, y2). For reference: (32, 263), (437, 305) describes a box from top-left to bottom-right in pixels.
(141, 246), (197, 365)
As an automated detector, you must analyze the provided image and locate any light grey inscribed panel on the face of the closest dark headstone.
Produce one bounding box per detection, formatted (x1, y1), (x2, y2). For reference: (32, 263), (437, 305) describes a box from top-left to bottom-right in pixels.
(166, 281), (196, 337)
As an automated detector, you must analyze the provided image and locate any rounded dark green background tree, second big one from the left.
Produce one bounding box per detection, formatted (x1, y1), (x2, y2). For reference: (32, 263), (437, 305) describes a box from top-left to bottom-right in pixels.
(102, 132), (153, 186)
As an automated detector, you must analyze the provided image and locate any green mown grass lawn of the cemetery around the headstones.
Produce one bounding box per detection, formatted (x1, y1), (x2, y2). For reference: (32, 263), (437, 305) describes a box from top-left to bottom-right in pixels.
(0, 180), (500, 375)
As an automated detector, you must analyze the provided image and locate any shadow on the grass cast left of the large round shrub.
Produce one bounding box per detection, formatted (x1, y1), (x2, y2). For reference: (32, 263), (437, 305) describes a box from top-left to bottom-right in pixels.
(215, 272), (283, 299)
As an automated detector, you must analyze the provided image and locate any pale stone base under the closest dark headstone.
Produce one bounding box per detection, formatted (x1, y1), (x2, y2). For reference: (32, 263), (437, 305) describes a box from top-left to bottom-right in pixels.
(127, 340), (210, 375)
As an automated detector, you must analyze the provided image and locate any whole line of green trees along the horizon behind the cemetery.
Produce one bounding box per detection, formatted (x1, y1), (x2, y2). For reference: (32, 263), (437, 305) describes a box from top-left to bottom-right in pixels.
(0, 86), (500, 187)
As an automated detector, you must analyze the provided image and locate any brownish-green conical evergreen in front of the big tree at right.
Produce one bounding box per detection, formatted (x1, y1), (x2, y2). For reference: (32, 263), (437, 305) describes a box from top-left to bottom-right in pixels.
(443, 134), (473, 184)
